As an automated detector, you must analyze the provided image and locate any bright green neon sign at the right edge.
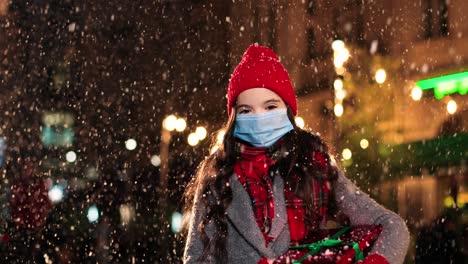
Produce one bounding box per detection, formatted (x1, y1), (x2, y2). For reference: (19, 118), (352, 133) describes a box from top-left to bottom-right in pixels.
(416, 72), (468, 100)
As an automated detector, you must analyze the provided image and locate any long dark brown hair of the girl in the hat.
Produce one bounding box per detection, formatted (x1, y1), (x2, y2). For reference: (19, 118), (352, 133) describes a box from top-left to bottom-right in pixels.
(184, 107), (338, 263)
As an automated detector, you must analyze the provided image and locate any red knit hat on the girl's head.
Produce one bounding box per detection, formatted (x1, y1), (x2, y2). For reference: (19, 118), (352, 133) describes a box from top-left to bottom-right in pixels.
(227, 44), (297, 115)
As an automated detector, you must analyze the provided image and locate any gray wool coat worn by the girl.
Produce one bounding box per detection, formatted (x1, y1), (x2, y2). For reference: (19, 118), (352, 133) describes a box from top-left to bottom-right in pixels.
(184, 168), (409, 264)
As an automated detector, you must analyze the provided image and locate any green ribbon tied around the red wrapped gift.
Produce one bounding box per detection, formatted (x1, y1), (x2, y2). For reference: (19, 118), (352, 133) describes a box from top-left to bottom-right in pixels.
(289, 226), (364, 264)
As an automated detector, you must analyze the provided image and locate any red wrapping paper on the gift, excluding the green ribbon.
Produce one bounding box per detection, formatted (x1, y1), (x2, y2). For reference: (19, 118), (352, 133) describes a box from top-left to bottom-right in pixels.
(273, 225), (382, 264)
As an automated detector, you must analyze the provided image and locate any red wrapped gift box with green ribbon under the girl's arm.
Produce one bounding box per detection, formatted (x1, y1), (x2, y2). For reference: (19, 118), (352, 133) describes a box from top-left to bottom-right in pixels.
(274, 225), (382, 264)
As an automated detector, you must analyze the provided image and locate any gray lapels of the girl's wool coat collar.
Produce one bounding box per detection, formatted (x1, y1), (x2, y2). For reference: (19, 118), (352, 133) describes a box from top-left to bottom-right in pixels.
(227, 171), (289, 258)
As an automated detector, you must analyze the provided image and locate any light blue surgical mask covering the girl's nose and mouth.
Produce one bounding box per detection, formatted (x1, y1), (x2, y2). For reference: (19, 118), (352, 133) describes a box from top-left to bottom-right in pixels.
(234, 108), (294, 147)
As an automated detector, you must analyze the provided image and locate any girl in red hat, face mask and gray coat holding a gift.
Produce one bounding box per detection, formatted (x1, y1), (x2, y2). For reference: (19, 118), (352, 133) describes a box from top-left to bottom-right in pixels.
(184, 44), (409, 264)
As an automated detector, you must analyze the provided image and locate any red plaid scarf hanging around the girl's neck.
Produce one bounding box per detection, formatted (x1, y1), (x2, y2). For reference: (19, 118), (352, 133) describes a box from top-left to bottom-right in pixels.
(234, 140), (330, 245)
